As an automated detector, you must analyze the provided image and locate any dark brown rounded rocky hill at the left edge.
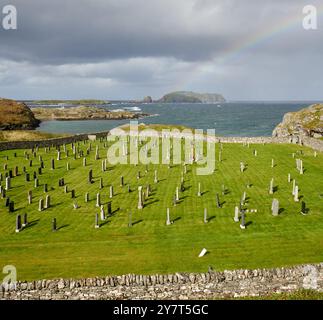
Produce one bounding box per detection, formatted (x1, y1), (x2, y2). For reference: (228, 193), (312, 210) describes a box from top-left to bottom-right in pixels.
(0, 98), (40, 130)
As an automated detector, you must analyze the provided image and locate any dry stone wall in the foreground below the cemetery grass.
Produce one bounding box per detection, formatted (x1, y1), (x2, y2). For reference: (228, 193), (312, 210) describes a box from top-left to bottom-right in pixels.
(0, 263), (323, 300)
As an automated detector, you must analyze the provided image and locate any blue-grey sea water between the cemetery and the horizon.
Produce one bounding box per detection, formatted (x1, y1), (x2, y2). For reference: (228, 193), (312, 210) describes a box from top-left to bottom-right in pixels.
(37, 102), (313, 137)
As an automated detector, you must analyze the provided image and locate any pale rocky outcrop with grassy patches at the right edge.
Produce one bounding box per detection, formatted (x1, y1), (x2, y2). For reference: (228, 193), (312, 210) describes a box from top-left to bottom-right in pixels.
(273, 104), (323, 138)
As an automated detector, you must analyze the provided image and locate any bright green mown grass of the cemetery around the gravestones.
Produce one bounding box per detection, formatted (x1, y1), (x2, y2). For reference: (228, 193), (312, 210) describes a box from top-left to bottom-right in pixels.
(0, 141), (323, 280)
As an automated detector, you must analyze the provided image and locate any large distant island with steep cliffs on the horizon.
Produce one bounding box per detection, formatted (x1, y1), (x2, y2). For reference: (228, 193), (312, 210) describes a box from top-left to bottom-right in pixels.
(158, 91), (225, 103)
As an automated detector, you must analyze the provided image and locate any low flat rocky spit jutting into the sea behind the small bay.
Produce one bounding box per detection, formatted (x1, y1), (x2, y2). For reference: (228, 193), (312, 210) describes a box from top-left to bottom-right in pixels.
(32, 106), (148, 121)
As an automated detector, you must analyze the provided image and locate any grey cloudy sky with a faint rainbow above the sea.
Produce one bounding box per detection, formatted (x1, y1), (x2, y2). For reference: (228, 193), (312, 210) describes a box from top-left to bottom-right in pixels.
(0, 0), (323, 100)
